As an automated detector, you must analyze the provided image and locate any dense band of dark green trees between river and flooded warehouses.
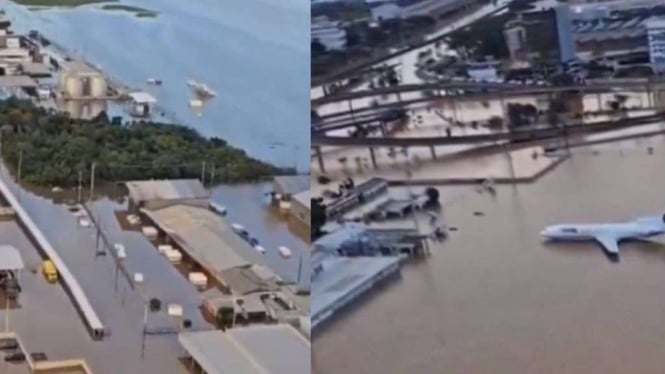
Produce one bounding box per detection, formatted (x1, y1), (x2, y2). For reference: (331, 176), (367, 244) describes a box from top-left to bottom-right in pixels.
(0, 98), (284, 187)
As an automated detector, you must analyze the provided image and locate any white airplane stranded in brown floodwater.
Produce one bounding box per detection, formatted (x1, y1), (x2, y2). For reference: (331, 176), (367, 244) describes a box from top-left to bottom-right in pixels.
(540, 215), (665, 256)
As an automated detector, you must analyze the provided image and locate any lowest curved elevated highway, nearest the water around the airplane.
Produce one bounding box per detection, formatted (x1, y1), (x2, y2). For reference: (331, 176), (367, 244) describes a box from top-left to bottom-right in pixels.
(312, 114), (665, 147)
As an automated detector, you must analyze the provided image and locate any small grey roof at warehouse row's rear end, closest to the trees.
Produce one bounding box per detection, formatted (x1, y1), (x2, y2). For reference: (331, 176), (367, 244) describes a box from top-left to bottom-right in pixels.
(125, 179), (210, 201)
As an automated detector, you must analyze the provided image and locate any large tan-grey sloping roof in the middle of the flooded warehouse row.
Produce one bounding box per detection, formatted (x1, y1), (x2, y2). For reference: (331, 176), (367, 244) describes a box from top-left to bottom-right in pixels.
(143, 205), (265, 278)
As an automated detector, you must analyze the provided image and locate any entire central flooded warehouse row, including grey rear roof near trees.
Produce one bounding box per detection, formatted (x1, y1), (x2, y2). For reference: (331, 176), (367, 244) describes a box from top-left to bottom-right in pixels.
(126, 180), (308, 322)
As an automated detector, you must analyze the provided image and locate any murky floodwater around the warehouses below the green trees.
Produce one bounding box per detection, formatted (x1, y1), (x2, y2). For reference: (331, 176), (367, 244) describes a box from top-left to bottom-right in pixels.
(0, 171), (309, 374)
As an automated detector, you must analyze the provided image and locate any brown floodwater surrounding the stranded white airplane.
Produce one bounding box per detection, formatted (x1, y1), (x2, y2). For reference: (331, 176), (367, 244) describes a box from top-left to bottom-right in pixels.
(312, 136), (665, 374)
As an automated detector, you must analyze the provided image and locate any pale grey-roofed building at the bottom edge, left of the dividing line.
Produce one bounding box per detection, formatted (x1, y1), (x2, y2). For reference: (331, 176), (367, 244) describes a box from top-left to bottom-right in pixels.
(178, 324), (312, 374)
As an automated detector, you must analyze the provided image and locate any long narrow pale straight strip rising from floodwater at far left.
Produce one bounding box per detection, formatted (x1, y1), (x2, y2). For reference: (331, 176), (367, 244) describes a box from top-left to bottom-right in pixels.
(0, 169), (105, 340)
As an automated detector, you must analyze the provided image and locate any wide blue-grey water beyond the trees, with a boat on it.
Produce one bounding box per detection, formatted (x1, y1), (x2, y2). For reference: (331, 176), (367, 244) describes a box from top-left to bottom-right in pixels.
(3, 0), (310, 168)
